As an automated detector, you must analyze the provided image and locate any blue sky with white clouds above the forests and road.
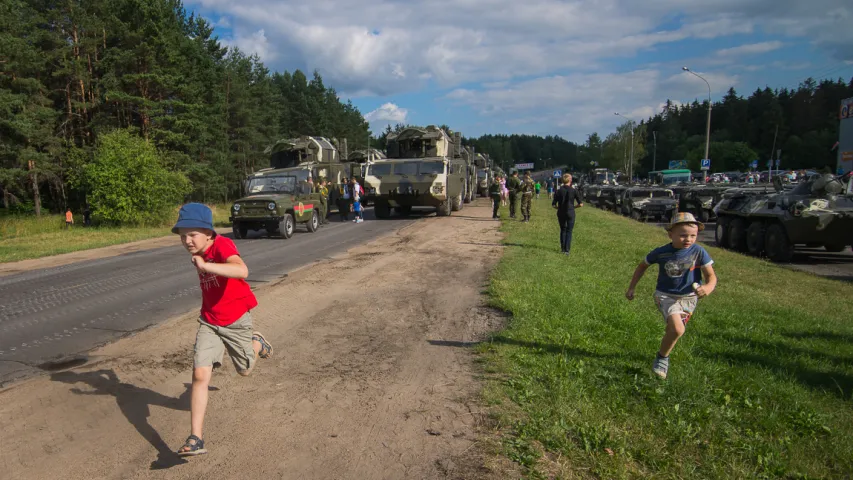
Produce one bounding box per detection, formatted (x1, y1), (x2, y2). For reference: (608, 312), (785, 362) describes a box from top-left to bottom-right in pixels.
(186, 0), (853, 142)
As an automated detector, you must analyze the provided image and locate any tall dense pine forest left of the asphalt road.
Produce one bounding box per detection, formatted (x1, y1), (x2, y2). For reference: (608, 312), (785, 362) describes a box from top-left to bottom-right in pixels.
(0, 0), (368, 213)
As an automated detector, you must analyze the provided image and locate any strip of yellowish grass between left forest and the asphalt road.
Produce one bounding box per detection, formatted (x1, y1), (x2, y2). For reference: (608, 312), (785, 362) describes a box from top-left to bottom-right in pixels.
(0, 204), (230, 263)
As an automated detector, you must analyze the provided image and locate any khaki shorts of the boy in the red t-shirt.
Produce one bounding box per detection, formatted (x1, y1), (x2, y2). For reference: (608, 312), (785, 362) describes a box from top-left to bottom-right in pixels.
(193, 312), (257, 375)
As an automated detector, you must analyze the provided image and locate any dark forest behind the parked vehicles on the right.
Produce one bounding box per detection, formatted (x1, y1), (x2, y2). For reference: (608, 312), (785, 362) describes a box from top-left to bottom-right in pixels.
(579, 78), (853, 174)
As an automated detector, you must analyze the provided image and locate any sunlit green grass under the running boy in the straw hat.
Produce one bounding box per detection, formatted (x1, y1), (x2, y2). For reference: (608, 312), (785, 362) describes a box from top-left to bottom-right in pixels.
(479, 199), (853, 479)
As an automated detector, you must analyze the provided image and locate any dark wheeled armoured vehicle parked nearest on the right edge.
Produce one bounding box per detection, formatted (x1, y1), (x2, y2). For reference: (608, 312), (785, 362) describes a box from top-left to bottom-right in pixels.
(714, 174), (853, 262)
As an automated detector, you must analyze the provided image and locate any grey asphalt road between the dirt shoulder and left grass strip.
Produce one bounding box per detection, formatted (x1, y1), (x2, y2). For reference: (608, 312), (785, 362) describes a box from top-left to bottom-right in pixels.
(0, 209), (419, 386)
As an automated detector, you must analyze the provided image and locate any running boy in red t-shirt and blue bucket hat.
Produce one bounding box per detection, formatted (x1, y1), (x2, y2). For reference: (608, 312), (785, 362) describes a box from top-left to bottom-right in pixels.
(172, 203), (273, 456)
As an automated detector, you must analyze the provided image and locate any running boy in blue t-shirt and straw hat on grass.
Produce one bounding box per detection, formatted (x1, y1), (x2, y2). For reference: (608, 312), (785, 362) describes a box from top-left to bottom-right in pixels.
(625, 212), (717, 378)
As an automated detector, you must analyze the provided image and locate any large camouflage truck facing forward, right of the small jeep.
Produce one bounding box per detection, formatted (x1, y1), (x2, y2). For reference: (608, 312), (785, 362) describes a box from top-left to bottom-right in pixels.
(364, 126), (468, 218)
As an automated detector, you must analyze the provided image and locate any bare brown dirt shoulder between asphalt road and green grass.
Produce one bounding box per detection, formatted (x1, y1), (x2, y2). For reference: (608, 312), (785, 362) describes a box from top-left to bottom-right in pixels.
(0, 202), (502, 479)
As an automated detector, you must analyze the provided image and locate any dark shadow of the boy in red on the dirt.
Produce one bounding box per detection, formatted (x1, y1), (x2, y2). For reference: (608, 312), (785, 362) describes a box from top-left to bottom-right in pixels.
(50, 370), (216, 470)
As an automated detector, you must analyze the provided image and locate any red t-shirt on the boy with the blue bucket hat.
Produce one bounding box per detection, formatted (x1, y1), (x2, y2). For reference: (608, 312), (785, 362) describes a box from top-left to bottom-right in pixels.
(198, 235), (258, 327)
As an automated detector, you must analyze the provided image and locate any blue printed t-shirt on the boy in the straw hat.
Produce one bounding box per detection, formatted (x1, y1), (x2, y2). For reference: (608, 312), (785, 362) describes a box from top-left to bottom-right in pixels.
(646, 243), (714, 295)
